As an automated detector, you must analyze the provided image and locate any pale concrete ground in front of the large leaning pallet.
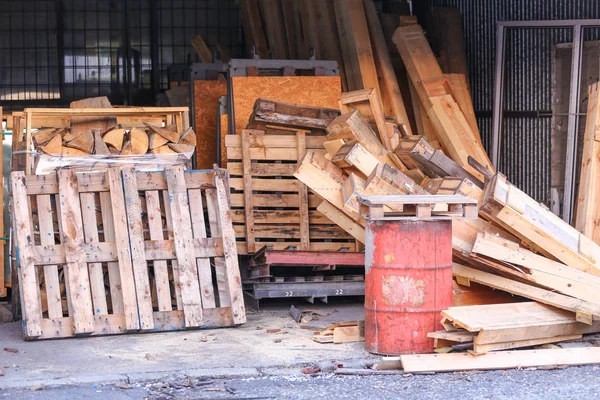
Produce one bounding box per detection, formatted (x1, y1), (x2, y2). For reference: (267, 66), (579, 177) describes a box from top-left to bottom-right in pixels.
(0, 299), (377, 388)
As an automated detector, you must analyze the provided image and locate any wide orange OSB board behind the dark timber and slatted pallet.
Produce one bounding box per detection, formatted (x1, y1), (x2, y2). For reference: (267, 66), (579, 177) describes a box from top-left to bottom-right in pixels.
(232, 76), (342, 134)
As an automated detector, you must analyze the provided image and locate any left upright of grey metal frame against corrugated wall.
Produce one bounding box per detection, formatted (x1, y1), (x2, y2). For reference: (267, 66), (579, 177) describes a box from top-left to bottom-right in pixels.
(491, 23), (506, 170)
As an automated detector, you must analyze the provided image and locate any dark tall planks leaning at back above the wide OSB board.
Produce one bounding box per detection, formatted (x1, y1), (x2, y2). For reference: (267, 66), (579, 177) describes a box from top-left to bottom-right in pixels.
(240, 0), (412, 138)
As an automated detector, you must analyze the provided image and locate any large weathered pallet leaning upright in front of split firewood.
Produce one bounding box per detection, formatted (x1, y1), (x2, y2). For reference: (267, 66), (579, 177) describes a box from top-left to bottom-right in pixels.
(11, 166), (246, 339)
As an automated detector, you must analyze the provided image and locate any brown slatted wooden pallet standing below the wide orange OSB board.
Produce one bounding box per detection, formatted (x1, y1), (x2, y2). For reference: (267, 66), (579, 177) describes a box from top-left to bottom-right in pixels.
(225, 127), (357, 254)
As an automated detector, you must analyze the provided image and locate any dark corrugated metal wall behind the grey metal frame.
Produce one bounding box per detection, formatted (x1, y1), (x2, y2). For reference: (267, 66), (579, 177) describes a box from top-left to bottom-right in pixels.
(429, 0), (600, 202)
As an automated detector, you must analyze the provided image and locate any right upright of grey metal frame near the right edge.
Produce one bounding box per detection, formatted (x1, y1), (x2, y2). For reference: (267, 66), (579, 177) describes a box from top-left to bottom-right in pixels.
(562, 24), (583, 223)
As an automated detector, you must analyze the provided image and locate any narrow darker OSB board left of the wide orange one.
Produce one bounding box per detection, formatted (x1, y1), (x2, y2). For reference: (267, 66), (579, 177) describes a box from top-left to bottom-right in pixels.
(194, 81), (227, 169)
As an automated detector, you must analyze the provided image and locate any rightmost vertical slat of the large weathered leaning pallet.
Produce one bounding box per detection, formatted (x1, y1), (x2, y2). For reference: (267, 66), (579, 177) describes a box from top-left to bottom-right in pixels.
(213, 173), (246, 324)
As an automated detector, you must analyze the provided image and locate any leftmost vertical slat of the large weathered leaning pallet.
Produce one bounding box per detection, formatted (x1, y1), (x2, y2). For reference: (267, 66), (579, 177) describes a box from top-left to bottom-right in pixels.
(11, 172), (43, 338)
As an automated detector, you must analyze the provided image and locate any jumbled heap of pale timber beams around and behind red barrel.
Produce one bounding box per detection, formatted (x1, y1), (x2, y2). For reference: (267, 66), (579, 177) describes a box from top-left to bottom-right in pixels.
(282, 19), (600, 368)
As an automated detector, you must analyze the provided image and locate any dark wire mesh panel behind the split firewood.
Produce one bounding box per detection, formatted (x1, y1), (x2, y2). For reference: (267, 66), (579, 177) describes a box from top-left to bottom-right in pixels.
(0, 0), (242, 109)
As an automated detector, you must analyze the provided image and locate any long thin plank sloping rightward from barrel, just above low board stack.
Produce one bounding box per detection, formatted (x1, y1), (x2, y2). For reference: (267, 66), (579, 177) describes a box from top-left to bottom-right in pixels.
(452, 263), (600, 325)
